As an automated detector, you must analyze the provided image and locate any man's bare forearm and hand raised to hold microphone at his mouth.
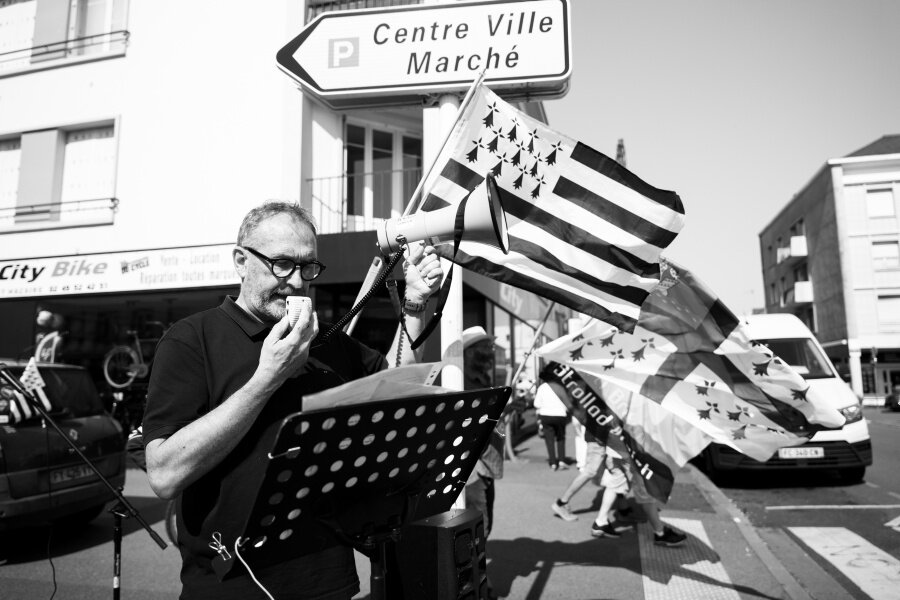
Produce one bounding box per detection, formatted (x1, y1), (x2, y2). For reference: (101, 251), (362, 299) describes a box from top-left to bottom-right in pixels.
(146, 313), (319, 498)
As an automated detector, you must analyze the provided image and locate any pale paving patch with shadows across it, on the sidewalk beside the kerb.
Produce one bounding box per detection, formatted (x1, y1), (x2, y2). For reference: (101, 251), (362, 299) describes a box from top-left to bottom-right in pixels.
(638, 518), (740, 600)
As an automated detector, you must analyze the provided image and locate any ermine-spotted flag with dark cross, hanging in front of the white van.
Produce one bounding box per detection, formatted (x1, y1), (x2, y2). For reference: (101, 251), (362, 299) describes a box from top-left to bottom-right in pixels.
(537, 260), (844, 461)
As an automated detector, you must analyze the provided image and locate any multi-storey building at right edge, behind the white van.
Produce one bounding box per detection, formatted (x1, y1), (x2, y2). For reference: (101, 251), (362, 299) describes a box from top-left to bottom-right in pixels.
(759, 135), (900, 404)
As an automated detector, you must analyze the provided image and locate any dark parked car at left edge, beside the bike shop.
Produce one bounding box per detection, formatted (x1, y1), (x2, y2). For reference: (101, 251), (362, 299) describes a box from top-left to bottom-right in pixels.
(0, 361), (126, 530)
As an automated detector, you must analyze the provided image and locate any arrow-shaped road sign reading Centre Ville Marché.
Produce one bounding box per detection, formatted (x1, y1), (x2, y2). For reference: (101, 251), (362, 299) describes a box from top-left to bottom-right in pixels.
(277, 0), (572, 108)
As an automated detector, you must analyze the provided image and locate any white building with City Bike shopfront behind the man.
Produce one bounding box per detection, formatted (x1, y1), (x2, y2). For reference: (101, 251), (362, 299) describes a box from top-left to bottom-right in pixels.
(0, 0), (570, 404)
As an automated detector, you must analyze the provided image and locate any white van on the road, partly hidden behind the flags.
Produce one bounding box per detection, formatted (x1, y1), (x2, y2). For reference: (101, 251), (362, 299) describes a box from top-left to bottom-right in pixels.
(699, 313), (872, 482)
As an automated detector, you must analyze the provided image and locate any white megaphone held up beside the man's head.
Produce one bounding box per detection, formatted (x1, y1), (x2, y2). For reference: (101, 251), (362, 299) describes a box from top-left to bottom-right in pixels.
(377, 173), (509, 255)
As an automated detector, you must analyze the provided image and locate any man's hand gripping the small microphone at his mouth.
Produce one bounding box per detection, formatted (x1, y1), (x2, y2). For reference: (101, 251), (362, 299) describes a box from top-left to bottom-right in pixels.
(256, 312), (319, 387)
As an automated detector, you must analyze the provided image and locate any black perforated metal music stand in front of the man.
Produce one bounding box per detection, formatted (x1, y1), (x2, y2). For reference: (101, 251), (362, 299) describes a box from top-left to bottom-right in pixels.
(236, 387), (512, 600)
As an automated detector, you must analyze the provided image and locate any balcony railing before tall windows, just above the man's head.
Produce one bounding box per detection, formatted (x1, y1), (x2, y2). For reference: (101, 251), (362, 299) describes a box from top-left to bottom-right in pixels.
(303, 168), (422, 233)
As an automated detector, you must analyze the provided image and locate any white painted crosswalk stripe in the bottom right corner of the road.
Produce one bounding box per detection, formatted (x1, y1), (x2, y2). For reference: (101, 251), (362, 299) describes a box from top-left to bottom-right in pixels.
(787, 527), (900, 600)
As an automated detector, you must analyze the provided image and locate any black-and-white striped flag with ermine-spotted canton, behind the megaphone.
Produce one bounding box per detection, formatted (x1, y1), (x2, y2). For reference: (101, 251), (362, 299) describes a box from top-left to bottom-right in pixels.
(420, 85), (684, 331)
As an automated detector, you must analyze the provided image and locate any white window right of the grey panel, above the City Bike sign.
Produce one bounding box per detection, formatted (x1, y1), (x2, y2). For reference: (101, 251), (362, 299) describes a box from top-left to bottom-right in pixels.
(60, 126), (116, 202)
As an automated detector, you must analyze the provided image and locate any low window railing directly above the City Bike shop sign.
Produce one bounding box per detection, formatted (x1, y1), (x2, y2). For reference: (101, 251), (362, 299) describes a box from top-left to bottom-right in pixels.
(0, 198), (119, 234)
